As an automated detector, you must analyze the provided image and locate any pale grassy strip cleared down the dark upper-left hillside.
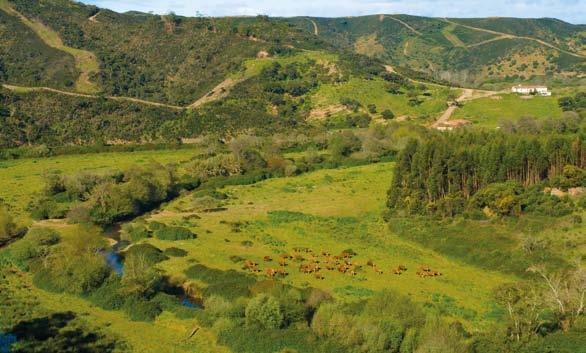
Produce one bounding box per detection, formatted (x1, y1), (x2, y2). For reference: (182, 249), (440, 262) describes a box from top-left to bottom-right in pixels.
(0, 0), (100, 93)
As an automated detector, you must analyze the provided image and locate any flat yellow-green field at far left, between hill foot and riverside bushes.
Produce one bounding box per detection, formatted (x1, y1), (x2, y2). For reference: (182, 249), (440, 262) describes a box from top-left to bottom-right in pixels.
(0, 149), (195, 222)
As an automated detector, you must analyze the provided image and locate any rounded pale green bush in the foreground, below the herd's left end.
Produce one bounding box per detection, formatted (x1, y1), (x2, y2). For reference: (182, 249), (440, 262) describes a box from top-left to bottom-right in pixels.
(245, 294), (283, 329)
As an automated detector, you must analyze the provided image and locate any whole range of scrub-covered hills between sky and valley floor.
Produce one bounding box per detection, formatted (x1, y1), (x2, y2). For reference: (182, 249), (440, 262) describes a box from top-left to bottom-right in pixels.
(0, 0), (586, 147)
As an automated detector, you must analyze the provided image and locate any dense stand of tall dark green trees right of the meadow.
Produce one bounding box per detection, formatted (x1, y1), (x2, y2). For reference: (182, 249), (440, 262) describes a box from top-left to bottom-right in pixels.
(388, 132), (586, 215)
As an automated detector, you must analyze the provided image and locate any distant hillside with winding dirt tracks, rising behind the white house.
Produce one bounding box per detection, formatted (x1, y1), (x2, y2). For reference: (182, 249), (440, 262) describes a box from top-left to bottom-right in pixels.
(294, 15), (586, 86)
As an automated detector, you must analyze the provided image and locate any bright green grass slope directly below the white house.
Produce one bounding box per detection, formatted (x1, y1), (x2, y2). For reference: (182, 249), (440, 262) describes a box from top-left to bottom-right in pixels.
(452, 94), (562, 128)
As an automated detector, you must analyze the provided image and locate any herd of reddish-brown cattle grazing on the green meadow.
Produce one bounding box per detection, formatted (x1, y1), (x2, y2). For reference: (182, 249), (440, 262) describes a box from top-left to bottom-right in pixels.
(243, 248), (442, 280)
